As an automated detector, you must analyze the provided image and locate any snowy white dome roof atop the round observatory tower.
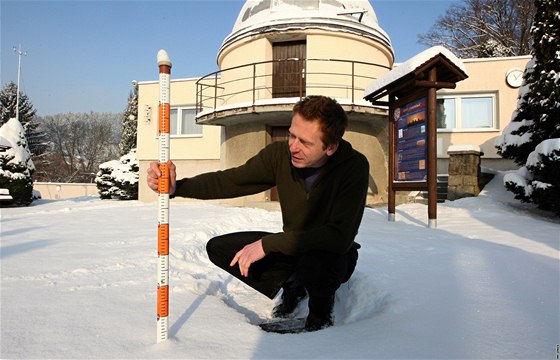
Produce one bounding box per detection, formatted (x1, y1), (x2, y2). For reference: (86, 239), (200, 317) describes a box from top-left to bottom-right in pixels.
(222, 0), (392, 49)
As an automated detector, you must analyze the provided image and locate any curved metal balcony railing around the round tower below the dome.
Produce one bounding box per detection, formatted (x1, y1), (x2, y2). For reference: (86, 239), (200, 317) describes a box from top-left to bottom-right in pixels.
(196, 58), (390, 115)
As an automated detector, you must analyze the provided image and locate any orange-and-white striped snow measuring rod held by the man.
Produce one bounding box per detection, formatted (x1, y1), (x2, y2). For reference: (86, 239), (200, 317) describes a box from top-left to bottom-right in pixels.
(157, 50), (171, 342)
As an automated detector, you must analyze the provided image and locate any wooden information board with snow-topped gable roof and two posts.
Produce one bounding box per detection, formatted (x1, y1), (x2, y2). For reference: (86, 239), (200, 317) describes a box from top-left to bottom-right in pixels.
(364, 46), (468, 228)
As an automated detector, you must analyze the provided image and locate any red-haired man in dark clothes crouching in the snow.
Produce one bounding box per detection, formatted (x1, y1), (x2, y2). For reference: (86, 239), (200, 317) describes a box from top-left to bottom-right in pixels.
(147, 96), (369, 331)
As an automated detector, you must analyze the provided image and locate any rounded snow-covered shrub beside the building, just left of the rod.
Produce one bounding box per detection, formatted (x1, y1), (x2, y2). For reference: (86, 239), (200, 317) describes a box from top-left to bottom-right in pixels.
(95, 149), (140, 200)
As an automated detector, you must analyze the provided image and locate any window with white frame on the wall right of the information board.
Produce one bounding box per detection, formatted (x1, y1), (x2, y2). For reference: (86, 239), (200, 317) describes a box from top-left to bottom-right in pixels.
(437, 94), (496, 130)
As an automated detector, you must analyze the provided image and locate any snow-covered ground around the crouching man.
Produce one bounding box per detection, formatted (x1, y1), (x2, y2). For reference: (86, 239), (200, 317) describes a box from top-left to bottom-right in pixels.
(0, 174), (560, 359)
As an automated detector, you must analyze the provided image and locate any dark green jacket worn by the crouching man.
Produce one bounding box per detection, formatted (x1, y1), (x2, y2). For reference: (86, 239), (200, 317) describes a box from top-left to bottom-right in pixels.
(175, 140), (369, 255)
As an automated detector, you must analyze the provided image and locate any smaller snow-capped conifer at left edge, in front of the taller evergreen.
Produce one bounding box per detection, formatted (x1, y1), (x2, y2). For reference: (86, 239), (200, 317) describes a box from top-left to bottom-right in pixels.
(0, 118), (35, 206)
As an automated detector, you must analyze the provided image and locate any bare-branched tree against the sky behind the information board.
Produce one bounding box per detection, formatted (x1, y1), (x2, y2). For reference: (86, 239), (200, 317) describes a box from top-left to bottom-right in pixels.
(418, 0), (535, 58)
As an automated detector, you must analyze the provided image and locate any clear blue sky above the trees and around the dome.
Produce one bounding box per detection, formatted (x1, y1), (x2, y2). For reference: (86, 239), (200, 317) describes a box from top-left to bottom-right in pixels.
(0, 0), (457, 115)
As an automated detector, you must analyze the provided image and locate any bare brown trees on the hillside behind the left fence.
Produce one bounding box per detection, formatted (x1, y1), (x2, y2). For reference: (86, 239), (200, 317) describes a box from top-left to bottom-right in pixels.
(36, 112), (120, 182)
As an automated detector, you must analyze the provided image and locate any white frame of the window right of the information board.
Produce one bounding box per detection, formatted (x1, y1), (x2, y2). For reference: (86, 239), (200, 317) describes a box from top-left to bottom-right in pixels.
(437, 91), (500, 133)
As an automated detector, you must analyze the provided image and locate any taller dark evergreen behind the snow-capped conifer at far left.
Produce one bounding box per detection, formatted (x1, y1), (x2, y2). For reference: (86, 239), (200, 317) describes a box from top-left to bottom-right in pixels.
(0, 82), (47, 156)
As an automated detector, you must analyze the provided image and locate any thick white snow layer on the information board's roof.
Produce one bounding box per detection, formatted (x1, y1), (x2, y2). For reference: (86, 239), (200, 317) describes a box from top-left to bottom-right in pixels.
(364, 46), (468, 97)
